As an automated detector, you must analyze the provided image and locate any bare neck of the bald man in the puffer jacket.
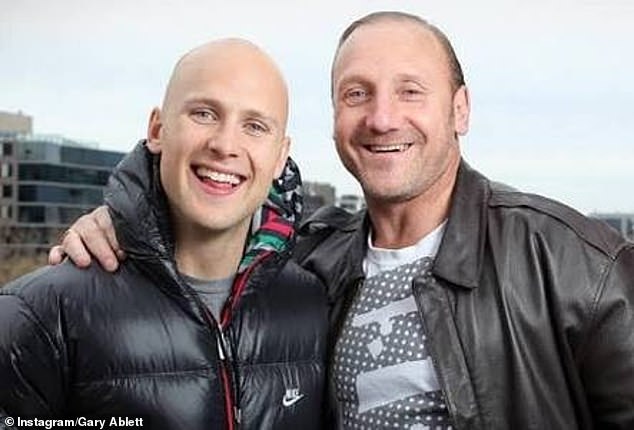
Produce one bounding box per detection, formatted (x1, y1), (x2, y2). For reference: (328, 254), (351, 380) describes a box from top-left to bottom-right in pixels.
(176, 218), (250, 279)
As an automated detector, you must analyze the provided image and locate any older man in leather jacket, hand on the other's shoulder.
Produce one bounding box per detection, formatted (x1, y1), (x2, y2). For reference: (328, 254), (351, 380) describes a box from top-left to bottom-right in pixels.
(56, 12), (634, 430)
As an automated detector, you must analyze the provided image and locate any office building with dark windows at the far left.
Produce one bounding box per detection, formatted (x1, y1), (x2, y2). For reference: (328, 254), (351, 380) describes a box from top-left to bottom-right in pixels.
(0, 112), (124, 255)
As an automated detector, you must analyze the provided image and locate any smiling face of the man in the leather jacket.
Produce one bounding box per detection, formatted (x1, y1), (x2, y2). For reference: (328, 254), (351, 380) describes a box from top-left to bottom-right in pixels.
(332, 19), (469, 205)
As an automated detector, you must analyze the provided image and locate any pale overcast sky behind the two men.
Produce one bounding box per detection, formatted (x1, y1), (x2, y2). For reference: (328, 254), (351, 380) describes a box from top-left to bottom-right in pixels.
(0, 0), (634, 213)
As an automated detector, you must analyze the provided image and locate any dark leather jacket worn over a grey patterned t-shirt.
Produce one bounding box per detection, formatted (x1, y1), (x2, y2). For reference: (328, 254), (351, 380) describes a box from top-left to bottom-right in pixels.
(298, 162), (634, 430)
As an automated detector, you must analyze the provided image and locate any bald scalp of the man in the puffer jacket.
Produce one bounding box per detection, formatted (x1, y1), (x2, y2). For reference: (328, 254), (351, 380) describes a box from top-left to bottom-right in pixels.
(163, 38), (288, 133)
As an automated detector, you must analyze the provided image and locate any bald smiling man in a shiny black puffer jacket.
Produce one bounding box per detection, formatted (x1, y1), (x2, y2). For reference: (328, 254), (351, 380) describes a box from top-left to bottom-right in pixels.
(0, 39), (327, 430)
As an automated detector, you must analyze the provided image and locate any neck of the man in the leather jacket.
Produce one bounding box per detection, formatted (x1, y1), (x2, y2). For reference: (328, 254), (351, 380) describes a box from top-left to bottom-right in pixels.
(367, 157), (460, 249)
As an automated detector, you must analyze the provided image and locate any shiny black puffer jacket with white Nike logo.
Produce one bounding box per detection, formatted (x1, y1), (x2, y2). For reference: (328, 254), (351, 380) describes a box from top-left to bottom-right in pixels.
(0, 144), (327, 430)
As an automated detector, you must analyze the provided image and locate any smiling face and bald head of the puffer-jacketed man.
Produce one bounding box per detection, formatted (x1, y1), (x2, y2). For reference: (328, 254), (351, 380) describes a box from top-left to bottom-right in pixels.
(148, 40), (289, 242)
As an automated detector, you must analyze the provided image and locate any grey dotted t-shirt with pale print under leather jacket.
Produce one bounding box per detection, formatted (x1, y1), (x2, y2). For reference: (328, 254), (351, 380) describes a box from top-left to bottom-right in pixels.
(334, 223), (452, 430)
